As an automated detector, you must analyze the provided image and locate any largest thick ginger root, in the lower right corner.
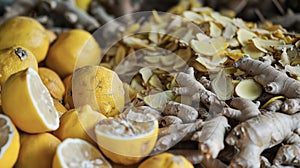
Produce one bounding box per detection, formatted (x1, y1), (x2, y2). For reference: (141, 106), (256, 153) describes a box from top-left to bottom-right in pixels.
(225, 113), (300, 167)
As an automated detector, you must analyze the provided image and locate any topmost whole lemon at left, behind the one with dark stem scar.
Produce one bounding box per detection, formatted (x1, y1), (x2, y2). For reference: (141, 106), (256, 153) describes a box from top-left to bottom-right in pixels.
(0, 16), (50, 62)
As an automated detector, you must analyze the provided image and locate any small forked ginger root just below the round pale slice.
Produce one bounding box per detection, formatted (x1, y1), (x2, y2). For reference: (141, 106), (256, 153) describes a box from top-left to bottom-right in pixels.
(223, 97), (260, 121)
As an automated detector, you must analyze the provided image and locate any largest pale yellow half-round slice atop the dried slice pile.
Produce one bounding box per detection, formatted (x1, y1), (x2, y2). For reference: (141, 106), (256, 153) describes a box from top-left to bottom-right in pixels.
(191, 37), (229, 56)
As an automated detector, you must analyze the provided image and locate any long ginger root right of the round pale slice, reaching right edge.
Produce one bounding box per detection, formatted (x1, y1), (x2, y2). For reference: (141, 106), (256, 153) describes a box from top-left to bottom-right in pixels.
(234, 56), (300, 98)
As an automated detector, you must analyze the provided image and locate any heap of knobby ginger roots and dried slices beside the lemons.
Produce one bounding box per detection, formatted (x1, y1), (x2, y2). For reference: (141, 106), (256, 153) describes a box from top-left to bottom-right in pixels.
(101, 1), (300, 167)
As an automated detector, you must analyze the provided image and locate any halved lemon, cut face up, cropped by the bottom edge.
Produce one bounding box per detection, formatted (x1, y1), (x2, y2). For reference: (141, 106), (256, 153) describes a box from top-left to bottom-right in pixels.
(52, 138), (111, 168)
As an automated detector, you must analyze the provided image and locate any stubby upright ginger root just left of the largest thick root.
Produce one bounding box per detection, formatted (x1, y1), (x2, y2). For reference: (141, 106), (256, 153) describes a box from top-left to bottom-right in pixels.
(192, 116), (230, 159)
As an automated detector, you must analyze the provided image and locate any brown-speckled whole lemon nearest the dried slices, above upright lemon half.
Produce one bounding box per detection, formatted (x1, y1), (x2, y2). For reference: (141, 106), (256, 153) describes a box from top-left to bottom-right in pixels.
(72, 65), (125, 117)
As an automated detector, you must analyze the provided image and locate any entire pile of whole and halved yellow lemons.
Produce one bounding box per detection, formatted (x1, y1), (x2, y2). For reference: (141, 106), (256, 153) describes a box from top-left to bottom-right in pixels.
(0, 16), (193, 168)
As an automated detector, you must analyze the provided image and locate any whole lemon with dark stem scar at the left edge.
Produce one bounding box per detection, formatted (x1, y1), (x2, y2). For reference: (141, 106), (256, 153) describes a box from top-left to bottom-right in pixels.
(0, 45), (38, 85)
